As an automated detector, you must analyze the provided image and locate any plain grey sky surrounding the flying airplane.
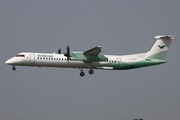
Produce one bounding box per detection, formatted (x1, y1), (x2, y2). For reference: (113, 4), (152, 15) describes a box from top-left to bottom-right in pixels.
(0, 0), (180, 120)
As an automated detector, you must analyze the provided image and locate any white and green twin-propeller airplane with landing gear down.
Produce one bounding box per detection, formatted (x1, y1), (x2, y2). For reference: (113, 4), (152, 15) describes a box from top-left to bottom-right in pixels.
(5, 35), (174, 77)
